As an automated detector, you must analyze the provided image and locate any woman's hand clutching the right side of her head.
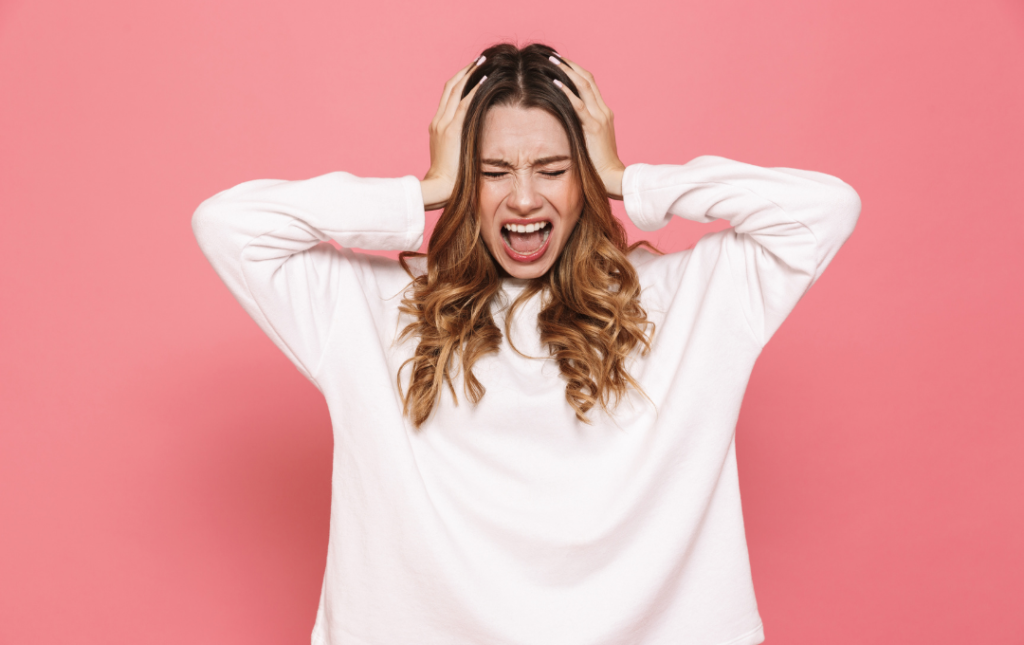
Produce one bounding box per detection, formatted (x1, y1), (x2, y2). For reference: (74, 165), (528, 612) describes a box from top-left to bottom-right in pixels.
(551, 56), (626, 200)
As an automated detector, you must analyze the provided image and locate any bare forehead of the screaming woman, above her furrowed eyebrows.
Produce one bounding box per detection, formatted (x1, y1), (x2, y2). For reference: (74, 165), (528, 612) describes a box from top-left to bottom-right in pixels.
(480, 105), (570, 163)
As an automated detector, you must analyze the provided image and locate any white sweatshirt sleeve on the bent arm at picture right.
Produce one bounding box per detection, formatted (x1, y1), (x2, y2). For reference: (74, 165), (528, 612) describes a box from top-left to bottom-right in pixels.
(623, 156), (860, 346)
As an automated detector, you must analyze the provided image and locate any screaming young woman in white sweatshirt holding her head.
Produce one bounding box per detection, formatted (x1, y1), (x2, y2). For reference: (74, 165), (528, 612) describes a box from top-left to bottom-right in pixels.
(193, 44), (860, 645)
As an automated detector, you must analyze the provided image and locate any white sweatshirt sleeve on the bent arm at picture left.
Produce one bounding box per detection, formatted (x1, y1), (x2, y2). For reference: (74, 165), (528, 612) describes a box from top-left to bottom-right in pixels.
(191, 171), (424, 387)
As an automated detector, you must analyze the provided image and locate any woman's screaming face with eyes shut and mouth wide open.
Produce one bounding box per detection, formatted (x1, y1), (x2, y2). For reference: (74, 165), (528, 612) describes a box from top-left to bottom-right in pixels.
(479, 105), (583, 278)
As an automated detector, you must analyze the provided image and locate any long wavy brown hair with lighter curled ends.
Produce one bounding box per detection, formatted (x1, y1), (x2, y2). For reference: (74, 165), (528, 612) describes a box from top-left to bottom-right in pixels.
(398, 43), (653, 428)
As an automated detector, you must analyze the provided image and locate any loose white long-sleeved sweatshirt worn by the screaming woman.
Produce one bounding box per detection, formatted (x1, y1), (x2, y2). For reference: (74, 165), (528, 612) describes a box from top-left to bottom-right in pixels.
(193, 157), (860, 645)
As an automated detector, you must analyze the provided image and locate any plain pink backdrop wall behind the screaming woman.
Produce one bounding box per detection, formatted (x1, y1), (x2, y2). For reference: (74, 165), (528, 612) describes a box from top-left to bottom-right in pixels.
(0, 0), (1024, 645)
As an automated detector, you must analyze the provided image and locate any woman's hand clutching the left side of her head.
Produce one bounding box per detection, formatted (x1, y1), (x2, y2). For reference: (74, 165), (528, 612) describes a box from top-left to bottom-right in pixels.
(420, 56), (487, 211)
